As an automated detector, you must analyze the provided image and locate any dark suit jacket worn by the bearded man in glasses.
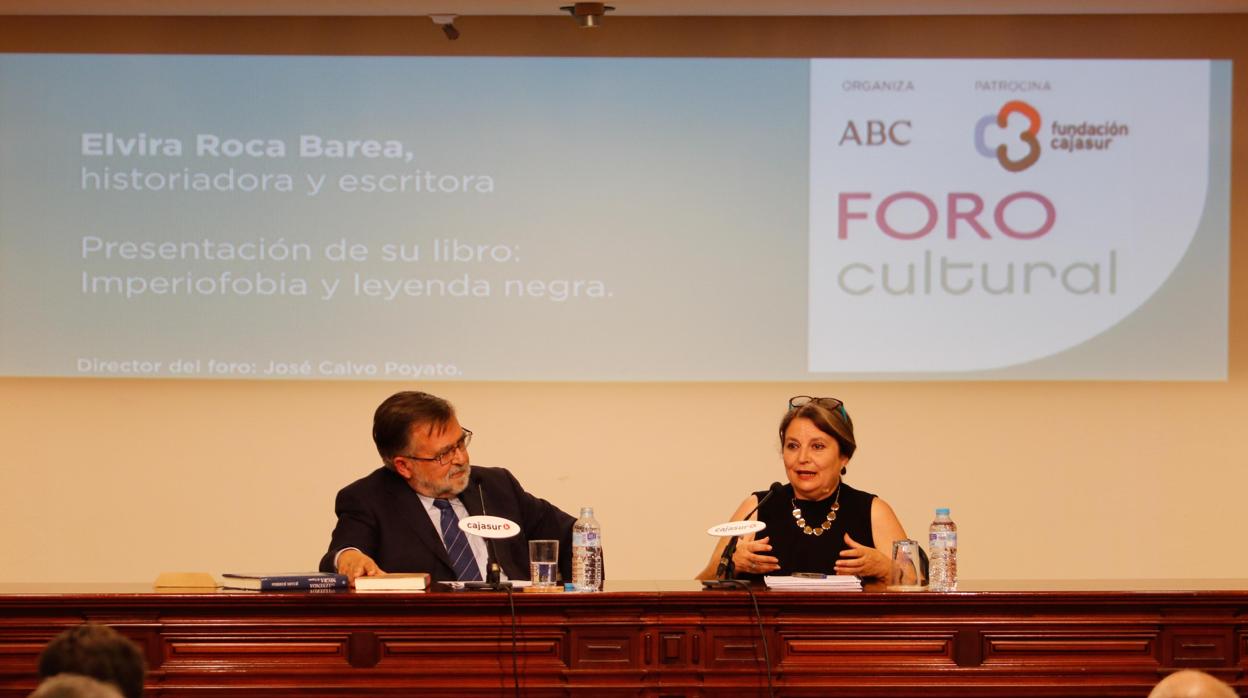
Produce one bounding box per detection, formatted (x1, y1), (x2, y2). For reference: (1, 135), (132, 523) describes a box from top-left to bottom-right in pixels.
(321, 466), (575, 582)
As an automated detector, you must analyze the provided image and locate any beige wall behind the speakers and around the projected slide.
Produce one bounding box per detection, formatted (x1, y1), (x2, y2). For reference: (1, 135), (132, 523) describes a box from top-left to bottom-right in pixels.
(0, 15), (1248, 581)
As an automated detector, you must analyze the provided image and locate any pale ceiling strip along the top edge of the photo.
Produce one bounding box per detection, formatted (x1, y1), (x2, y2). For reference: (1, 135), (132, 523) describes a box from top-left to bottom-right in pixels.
(7, 0), (1248, 16)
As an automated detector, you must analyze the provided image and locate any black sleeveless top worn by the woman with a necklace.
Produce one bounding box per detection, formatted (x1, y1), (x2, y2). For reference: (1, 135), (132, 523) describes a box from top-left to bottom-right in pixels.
(736, 479), (875, 581)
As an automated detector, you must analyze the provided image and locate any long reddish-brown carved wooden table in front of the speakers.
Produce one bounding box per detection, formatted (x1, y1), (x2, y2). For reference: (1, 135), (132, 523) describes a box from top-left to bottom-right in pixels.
(0, 579), (1248, 698)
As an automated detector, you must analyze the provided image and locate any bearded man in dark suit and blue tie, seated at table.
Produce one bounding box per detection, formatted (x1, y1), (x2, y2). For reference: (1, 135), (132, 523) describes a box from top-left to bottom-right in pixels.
(321, 392), (575, 582)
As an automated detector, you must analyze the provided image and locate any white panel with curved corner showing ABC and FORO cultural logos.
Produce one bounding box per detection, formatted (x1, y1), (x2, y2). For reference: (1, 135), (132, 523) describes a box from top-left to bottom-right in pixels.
(807, 60), (1211, 372)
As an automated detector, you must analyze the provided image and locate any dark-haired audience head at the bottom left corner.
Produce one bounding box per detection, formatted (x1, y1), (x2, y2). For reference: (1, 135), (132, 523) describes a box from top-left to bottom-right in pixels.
(39, 623), (147, 698)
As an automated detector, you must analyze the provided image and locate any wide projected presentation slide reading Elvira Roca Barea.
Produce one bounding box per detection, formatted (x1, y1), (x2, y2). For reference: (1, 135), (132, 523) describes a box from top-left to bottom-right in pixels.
(0, 54), (1232, 381)
